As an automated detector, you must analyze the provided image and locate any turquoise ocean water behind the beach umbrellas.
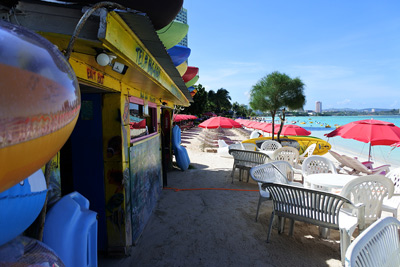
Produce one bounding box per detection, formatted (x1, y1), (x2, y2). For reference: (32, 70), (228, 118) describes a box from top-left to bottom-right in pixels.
(263, 115), (400, 168)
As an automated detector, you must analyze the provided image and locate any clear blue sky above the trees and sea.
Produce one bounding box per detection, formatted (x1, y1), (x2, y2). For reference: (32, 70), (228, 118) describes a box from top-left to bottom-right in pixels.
(183, 0), (400, 109)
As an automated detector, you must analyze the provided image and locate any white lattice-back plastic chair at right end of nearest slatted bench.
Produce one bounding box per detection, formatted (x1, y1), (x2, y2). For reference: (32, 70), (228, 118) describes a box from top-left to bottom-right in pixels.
(340, 175), (394, 231)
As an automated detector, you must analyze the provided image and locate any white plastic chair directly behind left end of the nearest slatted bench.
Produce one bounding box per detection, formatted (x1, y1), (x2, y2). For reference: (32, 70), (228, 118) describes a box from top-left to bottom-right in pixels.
(250, 161), (303, 221)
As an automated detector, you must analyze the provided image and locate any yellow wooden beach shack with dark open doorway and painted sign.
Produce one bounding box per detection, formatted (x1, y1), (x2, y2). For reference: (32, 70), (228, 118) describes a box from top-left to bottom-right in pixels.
(3, 1), (192, 254)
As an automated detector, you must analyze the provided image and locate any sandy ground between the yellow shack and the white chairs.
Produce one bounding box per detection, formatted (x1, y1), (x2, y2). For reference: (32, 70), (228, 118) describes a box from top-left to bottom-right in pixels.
(99, 128), (370, 267)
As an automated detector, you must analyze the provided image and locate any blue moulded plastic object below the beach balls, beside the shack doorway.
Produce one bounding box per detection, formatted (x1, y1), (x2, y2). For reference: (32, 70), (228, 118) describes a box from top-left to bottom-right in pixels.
(43, 192), (97, 267)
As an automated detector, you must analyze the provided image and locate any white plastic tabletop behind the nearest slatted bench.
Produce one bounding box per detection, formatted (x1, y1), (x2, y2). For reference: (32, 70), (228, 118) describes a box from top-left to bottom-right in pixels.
(306, 173), (358, 193)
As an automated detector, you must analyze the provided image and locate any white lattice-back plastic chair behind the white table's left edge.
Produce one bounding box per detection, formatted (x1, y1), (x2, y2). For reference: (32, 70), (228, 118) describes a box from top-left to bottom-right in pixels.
(301, 155), (337, 186)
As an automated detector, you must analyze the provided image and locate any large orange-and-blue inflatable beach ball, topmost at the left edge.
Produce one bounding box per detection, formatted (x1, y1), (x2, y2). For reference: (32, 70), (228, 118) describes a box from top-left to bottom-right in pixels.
(0, 20), (81, 192)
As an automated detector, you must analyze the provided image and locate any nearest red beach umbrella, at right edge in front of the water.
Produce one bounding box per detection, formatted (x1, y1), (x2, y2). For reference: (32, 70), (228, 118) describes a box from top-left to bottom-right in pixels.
(325, 119), (400, 161)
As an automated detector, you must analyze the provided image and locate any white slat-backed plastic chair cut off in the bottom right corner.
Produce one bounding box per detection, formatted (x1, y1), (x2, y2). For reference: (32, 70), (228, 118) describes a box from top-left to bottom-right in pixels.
(345, 217), (400, 267)
